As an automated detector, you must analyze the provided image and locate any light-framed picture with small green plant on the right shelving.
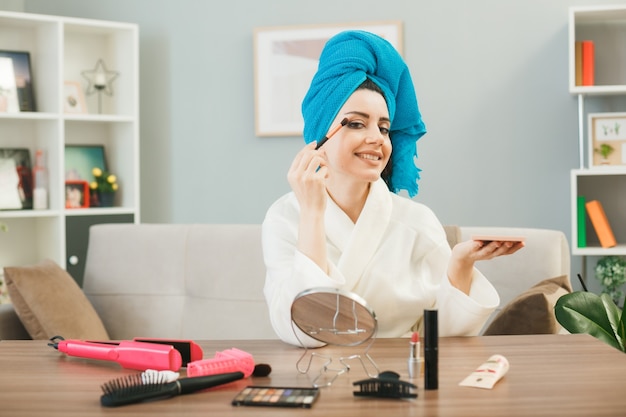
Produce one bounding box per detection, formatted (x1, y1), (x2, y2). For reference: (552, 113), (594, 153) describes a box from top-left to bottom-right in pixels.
(587, 113), (626, 168)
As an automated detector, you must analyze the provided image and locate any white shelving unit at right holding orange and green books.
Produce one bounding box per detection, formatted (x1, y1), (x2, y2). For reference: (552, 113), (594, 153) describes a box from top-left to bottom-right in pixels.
(569, 5), (626, 259)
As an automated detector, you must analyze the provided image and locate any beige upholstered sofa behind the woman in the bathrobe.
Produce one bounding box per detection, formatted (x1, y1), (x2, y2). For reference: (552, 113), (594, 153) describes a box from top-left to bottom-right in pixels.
(0, 224), (570, 340)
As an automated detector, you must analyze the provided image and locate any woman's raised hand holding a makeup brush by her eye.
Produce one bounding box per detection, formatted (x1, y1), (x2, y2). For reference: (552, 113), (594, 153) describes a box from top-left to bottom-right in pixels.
(287, 142), (328, 213)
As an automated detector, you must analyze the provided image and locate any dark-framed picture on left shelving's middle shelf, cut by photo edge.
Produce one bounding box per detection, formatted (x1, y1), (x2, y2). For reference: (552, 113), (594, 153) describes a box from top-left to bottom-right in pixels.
(0, 148), (33, 210)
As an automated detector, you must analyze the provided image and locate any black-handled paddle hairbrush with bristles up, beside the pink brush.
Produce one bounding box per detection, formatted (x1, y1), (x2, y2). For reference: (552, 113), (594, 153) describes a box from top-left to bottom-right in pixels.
(100, 372), (243, 407)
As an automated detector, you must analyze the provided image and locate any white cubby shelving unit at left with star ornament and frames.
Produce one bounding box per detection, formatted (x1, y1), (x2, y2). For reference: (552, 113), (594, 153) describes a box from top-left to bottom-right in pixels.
(0, 12), (139, 283)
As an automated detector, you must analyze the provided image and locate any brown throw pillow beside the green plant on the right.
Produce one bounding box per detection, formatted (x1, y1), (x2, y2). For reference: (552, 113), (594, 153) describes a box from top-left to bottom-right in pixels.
(483, 275), (572, 335)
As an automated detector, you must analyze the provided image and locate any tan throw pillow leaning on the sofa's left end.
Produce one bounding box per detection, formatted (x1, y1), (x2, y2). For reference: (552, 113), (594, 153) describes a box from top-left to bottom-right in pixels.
(4, 260), (109, 340)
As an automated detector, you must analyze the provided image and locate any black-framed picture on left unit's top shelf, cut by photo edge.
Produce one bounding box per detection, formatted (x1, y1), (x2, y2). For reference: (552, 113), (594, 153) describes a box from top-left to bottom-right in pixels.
(0, 50), (36, 112)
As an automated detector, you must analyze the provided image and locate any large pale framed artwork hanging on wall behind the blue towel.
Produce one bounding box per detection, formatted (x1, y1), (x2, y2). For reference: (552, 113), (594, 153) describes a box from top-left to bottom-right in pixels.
(254, 21), (402, 136)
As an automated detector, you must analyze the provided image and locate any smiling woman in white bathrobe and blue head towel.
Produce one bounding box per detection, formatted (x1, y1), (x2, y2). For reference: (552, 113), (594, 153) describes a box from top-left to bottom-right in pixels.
(263, 31), (523, 345)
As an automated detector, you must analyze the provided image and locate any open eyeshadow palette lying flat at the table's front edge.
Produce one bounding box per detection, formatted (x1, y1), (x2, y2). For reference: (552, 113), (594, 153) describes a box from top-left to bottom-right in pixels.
(232, 386), (319, 408)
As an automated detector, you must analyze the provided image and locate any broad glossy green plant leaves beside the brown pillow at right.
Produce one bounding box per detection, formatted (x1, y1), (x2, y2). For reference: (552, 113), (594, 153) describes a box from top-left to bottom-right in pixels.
(554, 291), (626, 352)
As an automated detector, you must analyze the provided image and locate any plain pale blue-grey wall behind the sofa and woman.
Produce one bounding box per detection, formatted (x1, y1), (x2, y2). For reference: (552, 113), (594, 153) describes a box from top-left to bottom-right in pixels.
(0, 0), (624, 292)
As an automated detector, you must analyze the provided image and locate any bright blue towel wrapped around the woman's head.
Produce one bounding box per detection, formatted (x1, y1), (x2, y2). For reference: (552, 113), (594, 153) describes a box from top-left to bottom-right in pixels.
(302, 30), (426, 197)
